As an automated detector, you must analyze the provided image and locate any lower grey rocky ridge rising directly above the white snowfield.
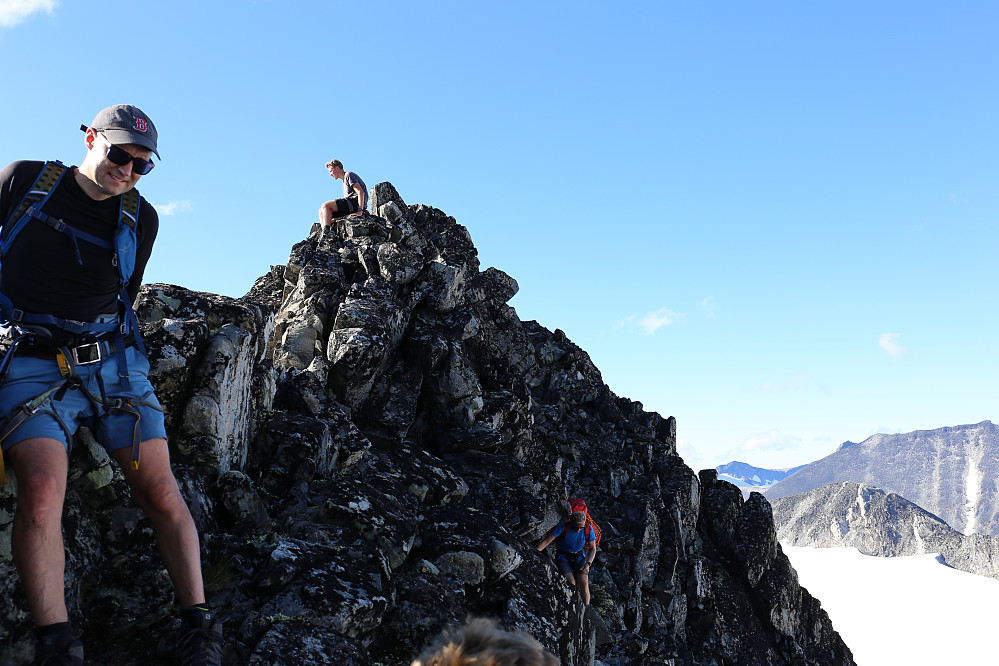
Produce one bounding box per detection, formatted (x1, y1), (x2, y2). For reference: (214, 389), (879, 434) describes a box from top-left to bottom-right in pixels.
(771, 483), (999, 578)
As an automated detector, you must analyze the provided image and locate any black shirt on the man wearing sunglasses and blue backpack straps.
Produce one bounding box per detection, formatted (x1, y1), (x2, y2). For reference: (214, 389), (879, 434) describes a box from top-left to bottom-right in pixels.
(0, 161), (159, 321)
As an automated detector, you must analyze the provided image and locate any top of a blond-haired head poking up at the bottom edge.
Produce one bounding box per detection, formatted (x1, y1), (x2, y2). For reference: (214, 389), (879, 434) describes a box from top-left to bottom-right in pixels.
(410, 618), (558, 666)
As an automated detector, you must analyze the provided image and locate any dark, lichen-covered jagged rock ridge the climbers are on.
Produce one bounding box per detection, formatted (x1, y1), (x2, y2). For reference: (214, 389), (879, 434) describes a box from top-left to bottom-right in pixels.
(0, 183), (853, 666)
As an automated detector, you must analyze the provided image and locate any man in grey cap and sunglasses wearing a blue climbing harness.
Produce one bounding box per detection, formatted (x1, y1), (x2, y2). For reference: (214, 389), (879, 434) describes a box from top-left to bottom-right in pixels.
(0, 105), (222, 665)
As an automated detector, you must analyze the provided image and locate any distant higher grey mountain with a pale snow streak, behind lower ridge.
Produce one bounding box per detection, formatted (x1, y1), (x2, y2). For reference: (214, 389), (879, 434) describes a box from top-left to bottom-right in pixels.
(764, 421), (999, 536)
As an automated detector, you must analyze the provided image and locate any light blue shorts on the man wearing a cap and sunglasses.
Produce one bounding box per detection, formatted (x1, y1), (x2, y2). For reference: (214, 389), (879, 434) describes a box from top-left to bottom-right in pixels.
(0, 347), (166, 453)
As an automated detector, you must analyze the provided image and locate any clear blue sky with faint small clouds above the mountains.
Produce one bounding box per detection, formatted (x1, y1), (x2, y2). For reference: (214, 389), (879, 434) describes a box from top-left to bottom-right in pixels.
(0, 0), (999, 468)
